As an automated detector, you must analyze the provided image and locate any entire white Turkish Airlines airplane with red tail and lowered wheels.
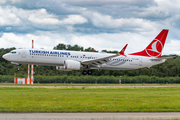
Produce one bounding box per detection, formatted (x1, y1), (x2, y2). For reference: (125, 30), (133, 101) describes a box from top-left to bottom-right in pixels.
(3, 29), (169, 75)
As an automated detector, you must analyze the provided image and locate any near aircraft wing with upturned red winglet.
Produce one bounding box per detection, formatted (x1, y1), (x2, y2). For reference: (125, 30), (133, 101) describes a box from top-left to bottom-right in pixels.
(81, 44), (128, 68)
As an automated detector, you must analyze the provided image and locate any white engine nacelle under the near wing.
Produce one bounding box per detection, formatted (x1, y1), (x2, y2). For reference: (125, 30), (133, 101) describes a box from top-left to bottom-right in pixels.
(64, 60), (81, 70)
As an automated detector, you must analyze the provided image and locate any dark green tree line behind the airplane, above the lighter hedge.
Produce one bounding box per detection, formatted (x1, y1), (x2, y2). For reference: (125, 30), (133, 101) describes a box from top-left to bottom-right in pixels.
(0, 44), (180, 77)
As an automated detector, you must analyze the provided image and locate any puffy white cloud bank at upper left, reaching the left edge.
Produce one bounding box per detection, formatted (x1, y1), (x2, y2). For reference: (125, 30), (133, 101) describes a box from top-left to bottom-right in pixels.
(0, 6), (88, 30)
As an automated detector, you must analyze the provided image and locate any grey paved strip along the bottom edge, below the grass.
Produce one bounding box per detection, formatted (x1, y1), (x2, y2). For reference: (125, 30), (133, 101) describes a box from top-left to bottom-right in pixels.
(0, 112), (180, 120)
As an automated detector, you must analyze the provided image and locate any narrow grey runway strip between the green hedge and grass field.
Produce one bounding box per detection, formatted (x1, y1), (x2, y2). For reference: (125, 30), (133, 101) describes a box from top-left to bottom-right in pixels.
(0, 84), (180, 87)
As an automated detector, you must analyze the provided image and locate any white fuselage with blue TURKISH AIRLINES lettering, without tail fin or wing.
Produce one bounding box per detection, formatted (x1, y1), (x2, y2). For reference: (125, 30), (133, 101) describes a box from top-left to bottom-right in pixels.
(3, 49), (165, 70)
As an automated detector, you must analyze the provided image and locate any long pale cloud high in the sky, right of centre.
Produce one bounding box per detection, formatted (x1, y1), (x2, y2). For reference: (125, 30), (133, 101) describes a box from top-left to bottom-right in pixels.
(84, 11), (154, 30)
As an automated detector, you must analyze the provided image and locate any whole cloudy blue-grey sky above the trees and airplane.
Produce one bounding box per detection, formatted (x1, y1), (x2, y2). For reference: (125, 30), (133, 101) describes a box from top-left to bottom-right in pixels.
(0, 0), (180, 55)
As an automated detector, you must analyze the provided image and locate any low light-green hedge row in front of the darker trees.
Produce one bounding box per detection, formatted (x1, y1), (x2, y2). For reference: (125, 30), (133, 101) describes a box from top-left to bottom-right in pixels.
(0, 75), (180, 84)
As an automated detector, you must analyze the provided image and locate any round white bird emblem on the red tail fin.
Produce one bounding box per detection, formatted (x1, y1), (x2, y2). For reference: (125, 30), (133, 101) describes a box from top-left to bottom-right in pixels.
(145, 39), (163, 57)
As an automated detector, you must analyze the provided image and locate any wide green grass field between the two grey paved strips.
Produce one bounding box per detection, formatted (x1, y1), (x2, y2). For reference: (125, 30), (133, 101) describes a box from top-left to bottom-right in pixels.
(0, 87), (180, 112)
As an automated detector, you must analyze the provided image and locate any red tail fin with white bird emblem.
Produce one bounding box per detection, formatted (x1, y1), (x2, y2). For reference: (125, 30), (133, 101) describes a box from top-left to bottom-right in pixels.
(129, 29), (169, 58)
